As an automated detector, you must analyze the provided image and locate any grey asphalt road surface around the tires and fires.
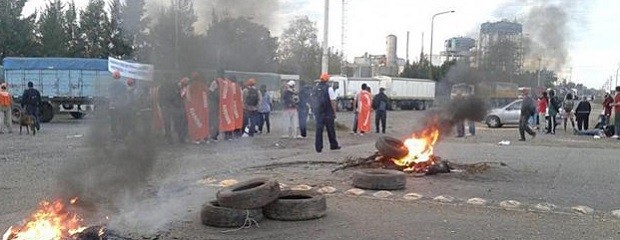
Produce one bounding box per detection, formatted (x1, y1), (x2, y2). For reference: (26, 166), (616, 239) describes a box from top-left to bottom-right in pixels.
(0, 111), (620, 239)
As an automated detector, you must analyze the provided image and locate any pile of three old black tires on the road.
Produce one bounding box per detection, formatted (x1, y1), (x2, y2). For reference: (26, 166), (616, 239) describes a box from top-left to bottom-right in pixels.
(200, 178), (327, 227)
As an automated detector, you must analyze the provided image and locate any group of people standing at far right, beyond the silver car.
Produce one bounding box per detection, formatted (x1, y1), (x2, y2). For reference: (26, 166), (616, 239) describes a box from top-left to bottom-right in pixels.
(519, 86), (620, 141)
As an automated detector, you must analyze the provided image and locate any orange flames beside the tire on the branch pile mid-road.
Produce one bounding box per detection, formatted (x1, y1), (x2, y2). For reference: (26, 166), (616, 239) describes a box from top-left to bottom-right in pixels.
(392, 126), (439, 172)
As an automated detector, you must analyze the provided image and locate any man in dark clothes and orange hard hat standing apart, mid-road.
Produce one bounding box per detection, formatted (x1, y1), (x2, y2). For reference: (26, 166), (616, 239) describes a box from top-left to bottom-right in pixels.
(312, 73), (341, 153)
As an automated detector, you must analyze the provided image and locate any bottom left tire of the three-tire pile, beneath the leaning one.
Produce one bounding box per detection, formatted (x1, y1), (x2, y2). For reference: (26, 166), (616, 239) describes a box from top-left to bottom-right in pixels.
(200, 200), (263, 227)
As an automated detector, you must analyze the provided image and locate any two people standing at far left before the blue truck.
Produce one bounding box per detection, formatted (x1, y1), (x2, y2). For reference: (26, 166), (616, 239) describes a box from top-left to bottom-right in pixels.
(0, 82), (42, 134)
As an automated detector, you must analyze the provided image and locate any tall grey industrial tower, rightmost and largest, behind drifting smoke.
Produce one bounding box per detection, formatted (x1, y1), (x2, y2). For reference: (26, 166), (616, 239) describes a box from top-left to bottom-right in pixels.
(476, 20), (523, 74)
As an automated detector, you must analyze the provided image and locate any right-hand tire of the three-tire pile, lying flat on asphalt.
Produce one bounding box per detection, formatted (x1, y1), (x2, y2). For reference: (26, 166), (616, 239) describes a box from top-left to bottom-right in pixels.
(263, 190), (327, 221)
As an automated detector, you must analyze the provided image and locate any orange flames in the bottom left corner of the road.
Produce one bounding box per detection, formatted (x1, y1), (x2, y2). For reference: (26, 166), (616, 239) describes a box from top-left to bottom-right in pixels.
(2, 198), (86, 240)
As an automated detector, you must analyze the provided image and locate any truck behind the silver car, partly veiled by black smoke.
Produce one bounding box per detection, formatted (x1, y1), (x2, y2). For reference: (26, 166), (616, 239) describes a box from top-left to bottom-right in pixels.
(450, 82), (519, 108)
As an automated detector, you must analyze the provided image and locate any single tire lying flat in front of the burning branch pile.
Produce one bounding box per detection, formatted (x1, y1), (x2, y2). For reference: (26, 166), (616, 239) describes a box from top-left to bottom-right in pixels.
(353, 169), (407, 190)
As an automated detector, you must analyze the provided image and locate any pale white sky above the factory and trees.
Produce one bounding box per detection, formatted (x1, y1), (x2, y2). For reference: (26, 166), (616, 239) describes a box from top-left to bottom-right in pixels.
(24, 0), (620, 88)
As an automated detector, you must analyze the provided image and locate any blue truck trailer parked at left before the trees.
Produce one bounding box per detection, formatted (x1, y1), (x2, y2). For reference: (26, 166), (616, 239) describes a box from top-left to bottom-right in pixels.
(2, 57), (112, 122)
